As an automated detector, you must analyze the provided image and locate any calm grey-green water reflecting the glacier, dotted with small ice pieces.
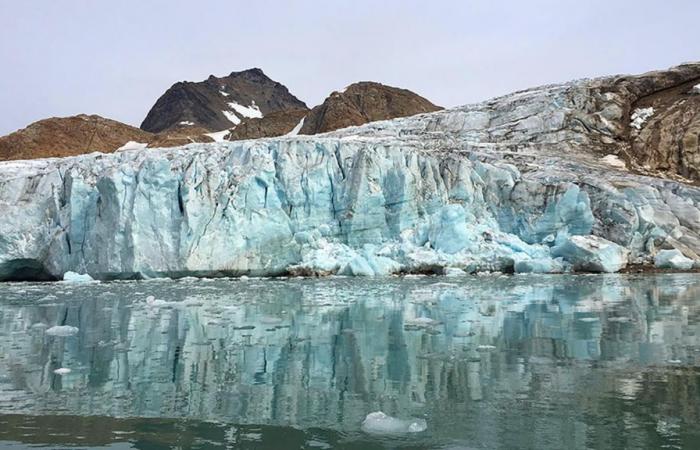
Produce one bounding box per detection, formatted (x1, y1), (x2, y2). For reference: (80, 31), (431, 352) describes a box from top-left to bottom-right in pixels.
(0, 274), (700, 449)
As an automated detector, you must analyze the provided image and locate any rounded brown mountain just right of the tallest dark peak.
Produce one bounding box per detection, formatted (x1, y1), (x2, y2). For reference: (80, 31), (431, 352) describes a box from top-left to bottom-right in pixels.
(300, 81), (442, 134)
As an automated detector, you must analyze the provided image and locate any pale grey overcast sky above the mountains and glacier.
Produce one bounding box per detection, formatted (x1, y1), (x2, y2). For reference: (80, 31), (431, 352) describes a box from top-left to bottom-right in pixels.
(0, 0), (700, 135)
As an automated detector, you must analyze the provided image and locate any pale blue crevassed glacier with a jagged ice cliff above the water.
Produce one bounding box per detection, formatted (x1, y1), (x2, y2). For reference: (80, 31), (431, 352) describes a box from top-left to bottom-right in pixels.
(0, 66), (700, 280)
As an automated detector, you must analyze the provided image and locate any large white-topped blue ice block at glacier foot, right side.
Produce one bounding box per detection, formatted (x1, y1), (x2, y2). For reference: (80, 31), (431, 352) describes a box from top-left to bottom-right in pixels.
(552, 235), (629, 272)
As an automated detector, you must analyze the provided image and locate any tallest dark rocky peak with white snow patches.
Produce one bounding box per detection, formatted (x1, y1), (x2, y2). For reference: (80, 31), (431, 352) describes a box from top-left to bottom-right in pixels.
(141, 68), (307, 133)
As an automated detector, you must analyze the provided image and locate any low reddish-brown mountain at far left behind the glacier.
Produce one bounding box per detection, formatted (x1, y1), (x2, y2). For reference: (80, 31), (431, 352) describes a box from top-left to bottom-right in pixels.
(0, 114), (152, 160)
